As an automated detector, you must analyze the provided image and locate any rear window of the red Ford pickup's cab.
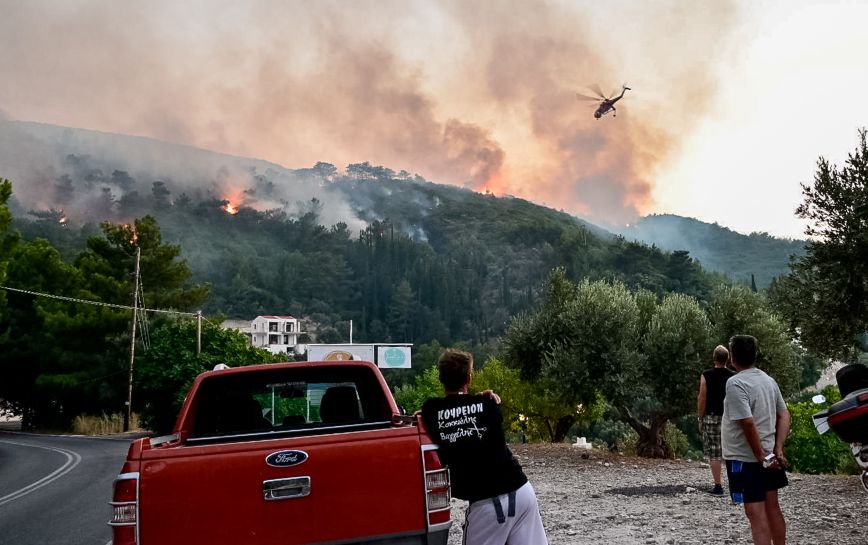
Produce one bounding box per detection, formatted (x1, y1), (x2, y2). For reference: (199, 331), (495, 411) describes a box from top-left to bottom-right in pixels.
(190, 367), (392, 442)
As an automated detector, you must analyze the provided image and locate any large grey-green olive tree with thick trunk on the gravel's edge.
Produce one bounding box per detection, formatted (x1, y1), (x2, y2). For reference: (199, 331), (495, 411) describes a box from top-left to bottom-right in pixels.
(504, 270), (710, 457)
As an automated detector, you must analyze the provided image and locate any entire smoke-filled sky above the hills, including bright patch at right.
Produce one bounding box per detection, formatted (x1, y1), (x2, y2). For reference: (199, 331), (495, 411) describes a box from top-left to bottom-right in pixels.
(0, 0), (868, 238)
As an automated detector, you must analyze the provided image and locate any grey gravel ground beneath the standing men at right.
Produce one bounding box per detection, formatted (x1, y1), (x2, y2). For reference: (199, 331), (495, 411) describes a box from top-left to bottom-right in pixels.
(449, 444), (868, 545)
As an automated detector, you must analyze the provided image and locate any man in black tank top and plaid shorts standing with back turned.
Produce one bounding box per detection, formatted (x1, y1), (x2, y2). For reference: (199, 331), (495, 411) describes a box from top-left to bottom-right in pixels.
(696, 345), (735, 496)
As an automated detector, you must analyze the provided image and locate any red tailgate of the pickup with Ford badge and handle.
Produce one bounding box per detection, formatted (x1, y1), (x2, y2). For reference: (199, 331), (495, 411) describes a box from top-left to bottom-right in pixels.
(139, 427), (426, 545)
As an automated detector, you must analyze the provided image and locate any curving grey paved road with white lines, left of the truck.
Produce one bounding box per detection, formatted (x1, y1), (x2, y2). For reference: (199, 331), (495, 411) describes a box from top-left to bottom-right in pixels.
(0, 431), (130, 545)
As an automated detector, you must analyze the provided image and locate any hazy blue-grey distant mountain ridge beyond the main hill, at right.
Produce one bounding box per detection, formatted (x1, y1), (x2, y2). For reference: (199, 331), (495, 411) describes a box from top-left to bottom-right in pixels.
(612, 214), (806, 288)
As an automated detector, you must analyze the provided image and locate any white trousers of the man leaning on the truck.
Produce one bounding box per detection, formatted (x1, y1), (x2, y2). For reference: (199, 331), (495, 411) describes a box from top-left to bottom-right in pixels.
(464, 481), (548, 545)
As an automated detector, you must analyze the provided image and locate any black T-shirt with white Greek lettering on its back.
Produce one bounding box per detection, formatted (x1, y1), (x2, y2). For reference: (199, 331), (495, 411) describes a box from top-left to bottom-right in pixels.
(422, 394), (527, 502)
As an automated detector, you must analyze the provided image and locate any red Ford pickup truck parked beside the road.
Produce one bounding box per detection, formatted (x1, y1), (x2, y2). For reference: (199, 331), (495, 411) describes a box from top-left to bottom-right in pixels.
(109, 361), (451, 545)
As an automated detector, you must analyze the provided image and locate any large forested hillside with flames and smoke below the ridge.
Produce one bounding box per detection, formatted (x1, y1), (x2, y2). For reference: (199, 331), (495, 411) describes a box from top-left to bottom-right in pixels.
(0, 123), (721, 345)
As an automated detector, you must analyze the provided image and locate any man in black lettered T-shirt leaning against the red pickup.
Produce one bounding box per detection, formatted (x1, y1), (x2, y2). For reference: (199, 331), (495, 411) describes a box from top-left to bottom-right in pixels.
(422, 350), (548, 545)
